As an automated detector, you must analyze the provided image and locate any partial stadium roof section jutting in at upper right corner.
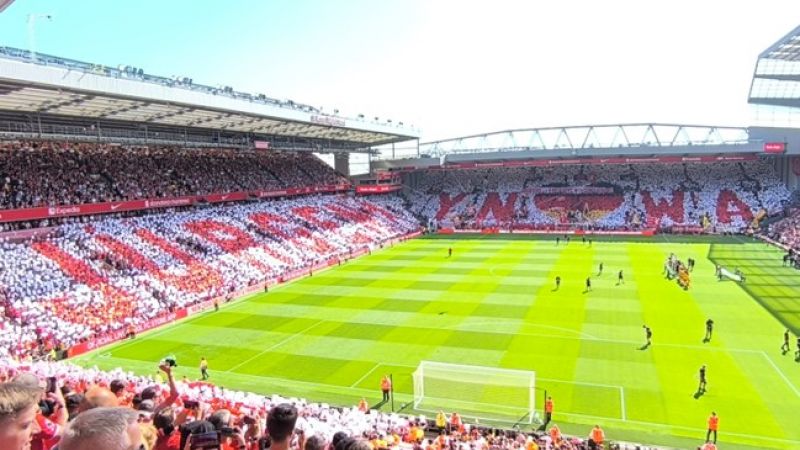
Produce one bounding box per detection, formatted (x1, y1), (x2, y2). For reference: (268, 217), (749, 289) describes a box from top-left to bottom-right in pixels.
(749, 26), (800, 108)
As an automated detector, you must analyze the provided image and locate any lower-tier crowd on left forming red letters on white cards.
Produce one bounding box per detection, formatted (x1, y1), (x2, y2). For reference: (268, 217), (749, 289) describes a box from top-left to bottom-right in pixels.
(0, 196), (419, 356)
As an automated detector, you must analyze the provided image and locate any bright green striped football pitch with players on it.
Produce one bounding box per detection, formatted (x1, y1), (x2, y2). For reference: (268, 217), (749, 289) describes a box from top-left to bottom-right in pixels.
(75, 235), (800, 449)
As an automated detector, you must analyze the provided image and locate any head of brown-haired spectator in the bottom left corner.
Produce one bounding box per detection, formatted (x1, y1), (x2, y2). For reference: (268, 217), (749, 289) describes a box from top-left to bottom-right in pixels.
(0, 383), (41, 450)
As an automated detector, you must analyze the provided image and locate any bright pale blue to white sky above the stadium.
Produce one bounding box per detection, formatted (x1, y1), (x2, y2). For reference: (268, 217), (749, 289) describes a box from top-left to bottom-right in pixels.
(0, 0), (800, 142)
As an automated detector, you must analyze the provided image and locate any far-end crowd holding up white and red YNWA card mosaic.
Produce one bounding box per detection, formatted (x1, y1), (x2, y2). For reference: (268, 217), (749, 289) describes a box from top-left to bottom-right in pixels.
(407, 160), (789, 232)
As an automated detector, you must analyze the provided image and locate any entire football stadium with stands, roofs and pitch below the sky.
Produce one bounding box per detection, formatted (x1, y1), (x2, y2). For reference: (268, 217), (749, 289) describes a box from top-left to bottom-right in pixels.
(0, 0), (800, 450)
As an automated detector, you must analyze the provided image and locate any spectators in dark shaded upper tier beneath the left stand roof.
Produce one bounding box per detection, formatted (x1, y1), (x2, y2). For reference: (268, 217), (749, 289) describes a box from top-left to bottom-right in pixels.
(0, 141), (348, 210)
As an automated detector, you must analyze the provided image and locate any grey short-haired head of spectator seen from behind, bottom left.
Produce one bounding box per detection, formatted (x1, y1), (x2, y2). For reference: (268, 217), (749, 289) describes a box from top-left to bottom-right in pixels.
(58, 406), (143, 450)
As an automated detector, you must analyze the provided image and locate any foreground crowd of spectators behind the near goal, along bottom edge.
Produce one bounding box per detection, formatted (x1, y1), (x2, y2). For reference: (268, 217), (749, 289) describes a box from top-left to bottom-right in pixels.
(0, 359), (654, 450)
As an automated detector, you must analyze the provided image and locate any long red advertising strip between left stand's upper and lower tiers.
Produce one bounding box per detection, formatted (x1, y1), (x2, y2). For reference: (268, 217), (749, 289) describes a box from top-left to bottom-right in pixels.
(0, 184), (351, 223)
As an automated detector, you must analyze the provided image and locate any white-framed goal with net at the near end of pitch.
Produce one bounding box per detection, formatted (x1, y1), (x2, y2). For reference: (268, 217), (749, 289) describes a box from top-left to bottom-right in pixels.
(414, 361), (536, 423)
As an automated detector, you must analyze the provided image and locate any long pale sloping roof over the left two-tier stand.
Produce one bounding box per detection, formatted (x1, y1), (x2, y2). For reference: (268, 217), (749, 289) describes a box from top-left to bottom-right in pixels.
(0, 47), (419, 148)
